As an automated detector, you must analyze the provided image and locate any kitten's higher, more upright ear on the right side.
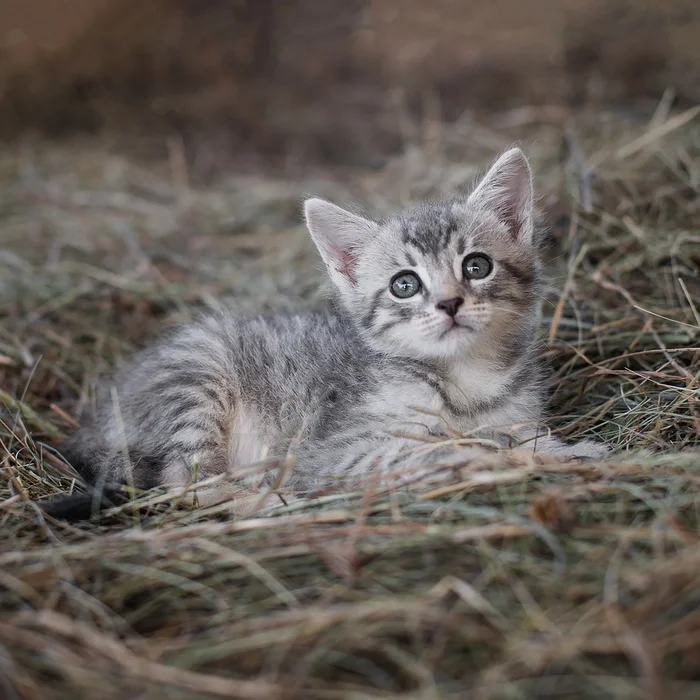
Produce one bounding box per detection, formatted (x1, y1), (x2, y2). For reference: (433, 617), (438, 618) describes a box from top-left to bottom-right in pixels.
(468, 148), (534, 243)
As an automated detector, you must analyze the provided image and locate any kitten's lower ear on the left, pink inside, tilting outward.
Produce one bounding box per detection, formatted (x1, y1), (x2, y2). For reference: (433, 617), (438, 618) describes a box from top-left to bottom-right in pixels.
(304, 197), (379, 289)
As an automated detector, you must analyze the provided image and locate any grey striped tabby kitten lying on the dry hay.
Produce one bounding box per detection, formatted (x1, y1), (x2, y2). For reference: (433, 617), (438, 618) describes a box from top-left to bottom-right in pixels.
(41, 148), (606, 520)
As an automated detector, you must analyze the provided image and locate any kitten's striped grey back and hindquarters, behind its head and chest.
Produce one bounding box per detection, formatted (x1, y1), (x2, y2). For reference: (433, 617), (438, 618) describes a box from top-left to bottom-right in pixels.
(65, 310), (377, 488)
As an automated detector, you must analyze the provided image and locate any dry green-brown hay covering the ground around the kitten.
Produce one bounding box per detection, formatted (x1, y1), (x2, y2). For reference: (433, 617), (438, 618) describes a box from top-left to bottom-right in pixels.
(0, 104), (700, 700)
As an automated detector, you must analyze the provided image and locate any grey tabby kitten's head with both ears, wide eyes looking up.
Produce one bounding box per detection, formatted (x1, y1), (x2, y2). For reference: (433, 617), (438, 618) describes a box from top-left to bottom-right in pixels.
(305, 148), (538, 361)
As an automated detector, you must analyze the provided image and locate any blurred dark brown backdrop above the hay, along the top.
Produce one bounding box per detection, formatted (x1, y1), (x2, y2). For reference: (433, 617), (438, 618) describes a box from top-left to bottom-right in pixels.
(0, 0), (700, 163)
